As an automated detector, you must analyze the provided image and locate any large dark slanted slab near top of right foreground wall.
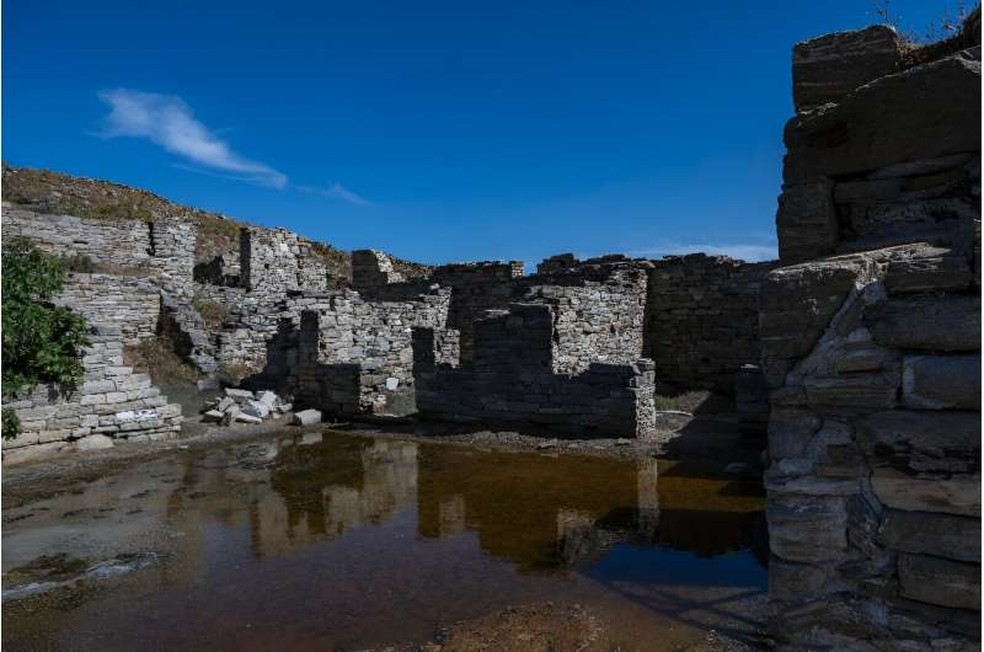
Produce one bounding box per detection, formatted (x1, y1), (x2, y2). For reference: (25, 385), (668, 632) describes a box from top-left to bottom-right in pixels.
(784, 55), (981, 183)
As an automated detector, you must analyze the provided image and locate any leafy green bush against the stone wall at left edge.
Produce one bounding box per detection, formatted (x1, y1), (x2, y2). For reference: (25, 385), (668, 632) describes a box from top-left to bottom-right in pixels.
(3, 238), (89, 400)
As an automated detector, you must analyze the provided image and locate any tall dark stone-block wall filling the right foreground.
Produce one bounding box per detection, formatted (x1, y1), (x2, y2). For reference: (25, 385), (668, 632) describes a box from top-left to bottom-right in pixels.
(761, 21), (981, 650)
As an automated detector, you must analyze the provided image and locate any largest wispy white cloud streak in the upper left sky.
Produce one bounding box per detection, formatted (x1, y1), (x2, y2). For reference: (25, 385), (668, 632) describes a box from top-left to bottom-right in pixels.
(99, 88), (287, 189)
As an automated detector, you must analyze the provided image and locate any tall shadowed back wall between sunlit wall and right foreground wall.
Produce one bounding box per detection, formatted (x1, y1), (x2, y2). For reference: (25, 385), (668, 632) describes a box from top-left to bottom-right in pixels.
(645, 254), (776, 394)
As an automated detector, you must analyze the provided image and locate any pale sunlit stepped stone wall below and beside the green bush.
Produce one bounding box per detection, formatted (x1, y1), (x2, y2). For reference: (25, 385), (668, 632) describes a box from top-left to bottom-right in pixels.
(3, 325), (181, 461)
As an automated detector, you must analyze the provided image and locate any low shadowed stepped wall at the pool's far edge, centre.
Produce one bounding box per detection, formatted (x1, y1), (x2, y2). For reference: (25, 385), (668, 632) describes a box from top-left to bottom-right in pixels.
(414, 304), (655, 437)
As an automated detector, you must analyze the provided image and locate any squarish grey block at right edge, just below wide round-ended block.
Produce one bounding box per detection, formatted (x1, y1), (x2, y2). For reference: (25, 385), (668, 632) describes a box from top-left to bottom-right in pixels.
(902, 355), (981, 410)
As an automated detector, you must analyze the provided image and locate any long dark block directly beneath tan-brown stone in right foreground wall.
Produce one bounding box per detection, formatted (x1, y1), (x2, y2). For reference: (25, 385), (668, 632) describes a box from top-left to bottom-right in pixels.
(878, 509), (981, 563)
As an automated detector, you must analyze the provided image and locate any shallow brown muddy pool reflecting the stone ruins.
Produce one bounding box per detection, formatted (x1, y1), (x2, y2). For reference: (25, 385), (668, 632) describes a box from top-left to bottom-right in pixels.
(3, 433), (766, 651)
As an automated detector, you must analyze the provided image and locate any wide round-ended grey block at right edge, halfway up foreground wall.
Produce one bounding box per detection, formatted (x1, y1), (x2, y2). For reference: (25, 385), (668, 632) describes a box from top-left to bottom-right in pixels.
(864, 296), (981, 351)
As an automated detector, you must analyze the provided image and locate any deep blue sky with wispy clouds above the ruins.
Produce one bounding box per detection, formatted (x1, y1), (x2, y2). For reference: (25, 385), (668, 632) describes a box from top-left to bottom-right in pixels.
(2, 0), (957, 263)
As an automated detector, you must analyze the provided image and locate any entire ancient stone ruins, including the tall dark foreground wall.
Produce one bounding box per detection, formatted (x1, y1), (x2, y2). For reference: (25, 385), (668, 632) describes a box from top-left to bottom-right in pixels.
(3, 11), (981, 650)
